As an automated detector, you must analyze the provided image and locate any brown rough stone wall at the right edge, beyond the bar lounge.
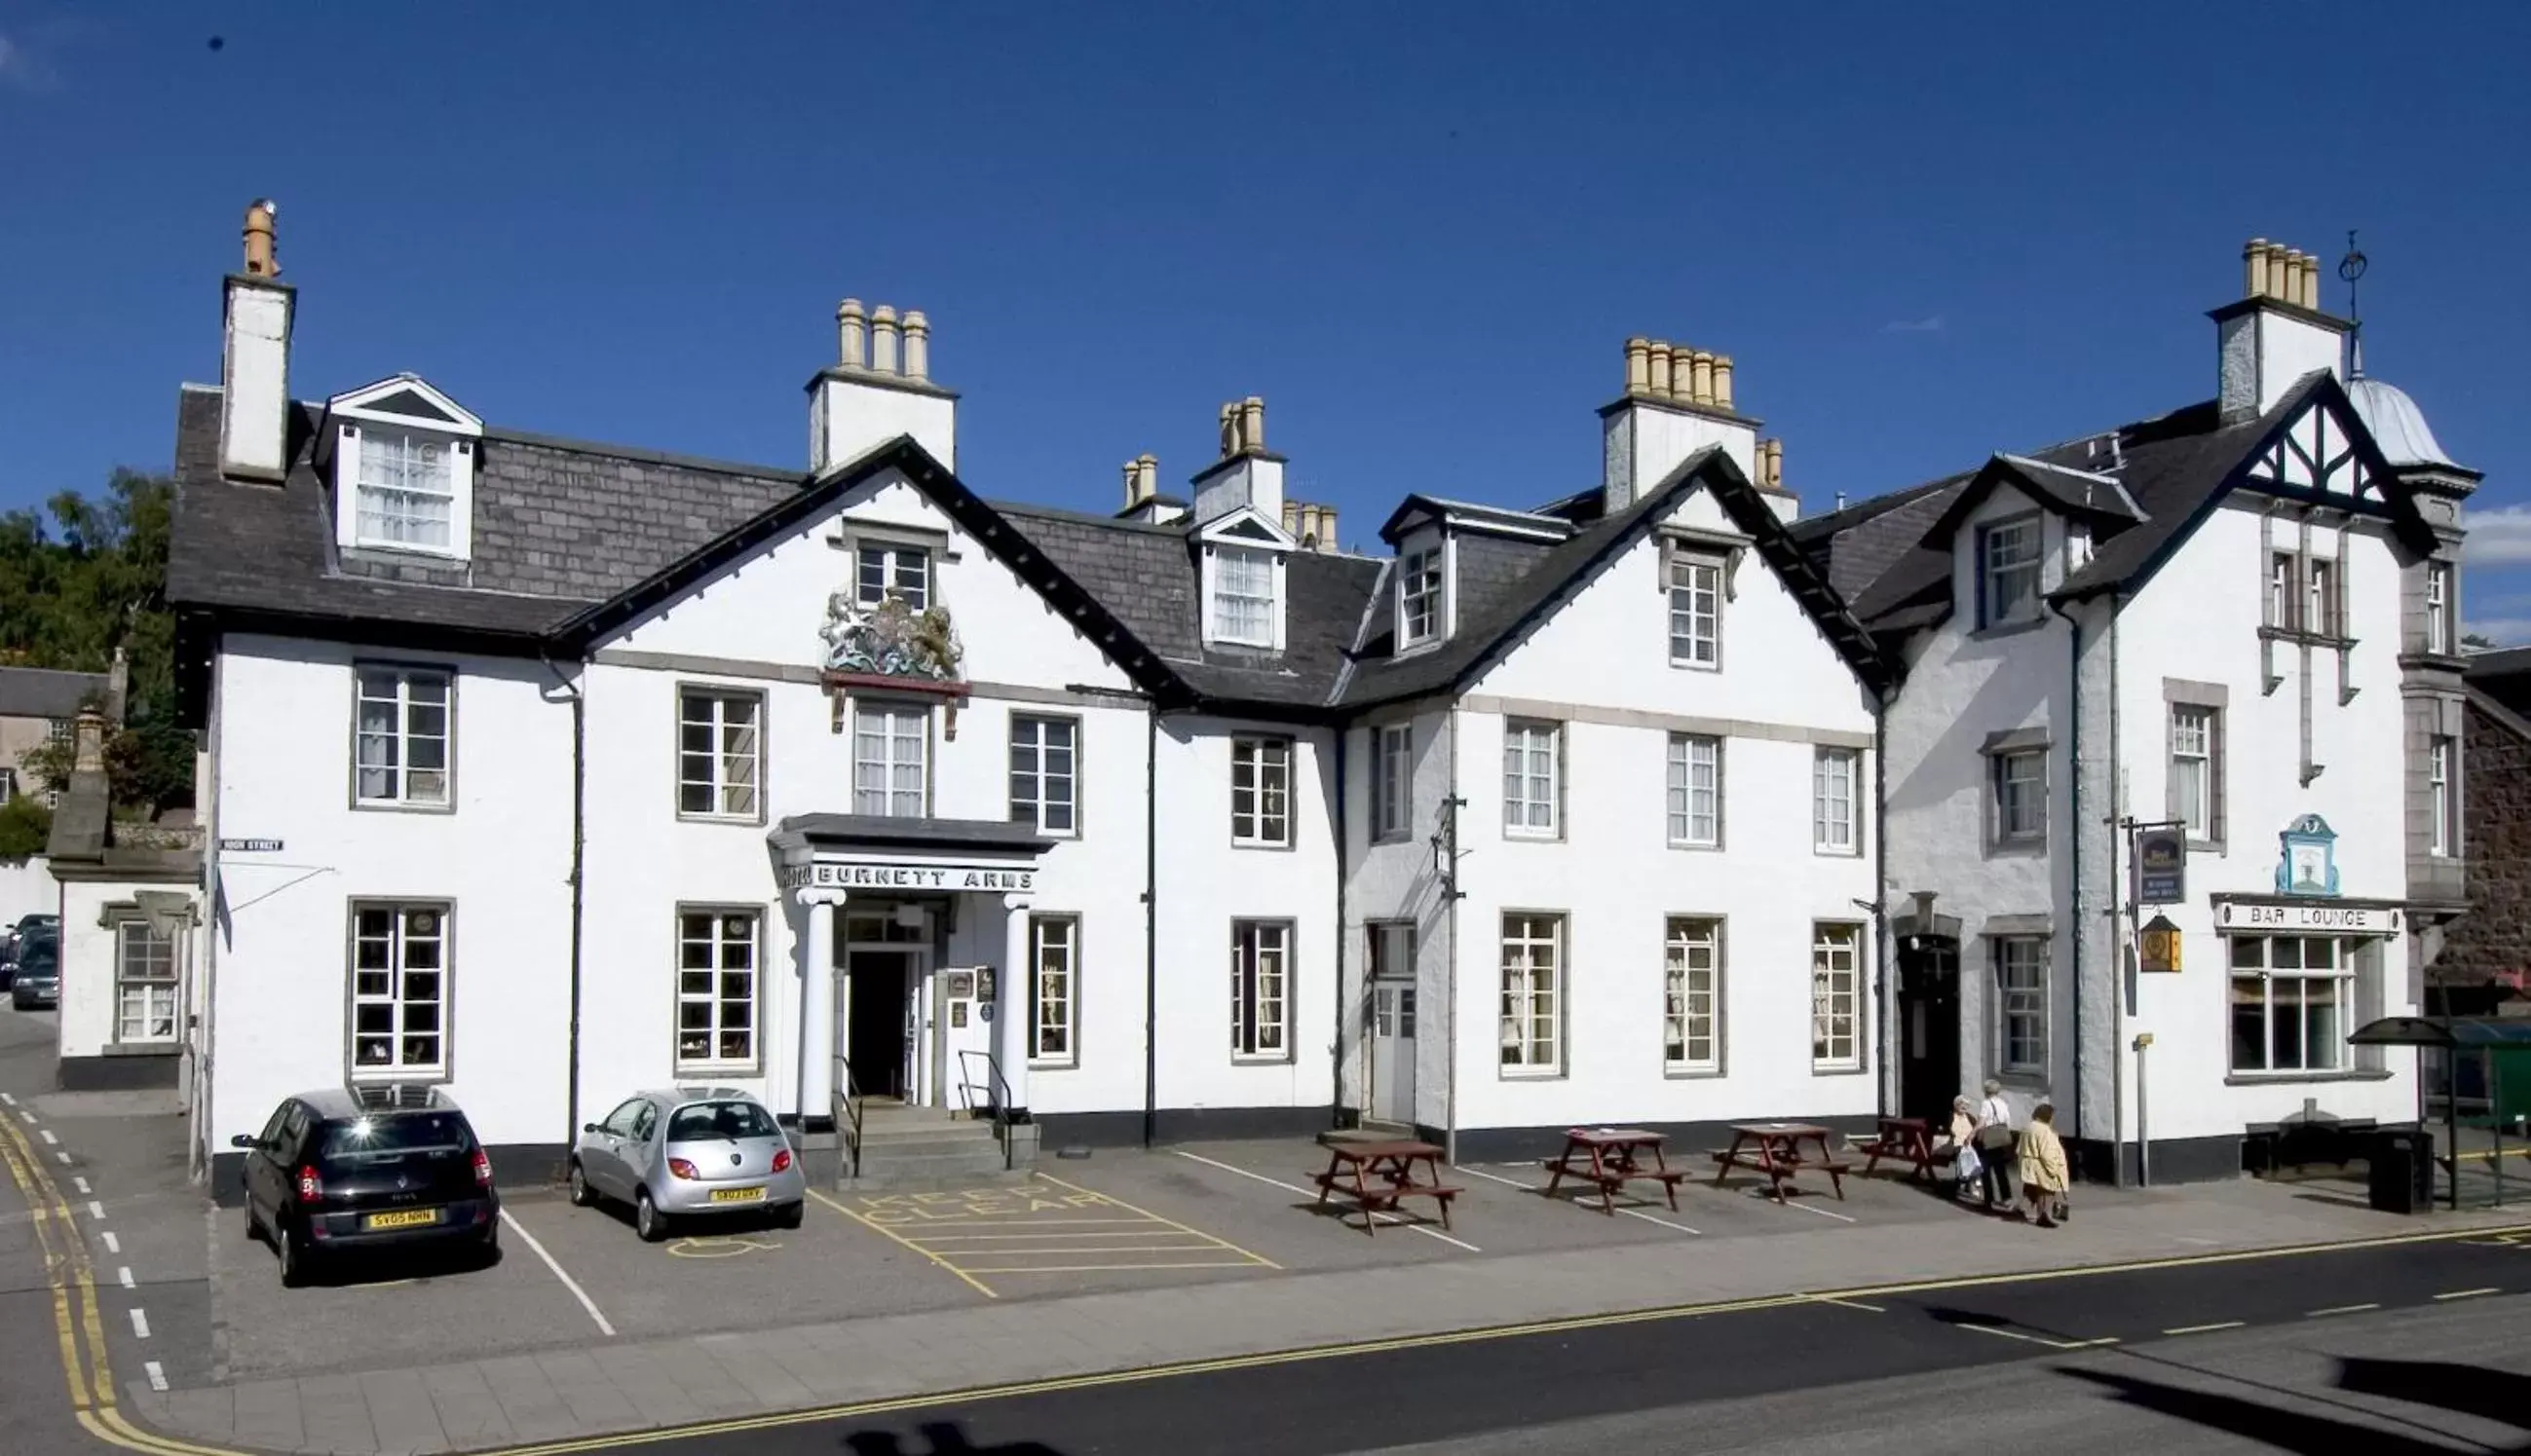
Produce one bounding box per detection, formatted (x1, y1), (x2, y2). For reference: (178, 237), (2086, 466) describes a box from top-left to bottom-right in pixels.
(2433, 701), (2531, 985)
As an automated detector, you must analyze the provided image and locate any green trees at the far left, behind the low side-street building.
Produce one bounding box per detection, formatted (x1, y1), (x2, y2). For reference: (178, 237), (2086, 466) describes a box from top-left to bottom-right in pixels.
(0, 468), (192, 813)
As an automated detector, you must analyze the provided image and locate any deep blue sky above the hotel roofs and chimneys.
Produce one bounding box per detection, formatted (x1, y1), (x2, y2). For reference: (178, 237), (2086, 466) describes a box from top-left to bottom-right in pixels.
(0, 0), (2531, 641)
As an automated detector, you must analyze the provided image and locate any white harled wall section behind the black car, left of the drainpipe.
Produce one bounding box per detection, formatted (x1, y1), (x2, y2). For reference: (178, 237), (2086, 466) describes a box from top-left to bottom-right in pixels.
(208, 633), (572, 1149)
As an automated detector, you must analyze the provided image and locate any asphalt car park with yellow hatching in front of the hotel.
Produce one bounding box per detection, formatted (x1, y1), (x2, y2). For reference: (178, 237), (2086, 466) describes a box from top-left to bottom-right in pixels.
(210, 1139), (1972, 1377)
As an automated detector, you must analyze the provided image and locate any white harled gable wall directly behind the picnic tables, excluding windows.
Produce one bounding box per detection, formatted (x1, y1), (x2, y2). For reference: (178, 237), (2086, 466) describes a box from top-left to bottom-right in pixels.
(1425, 494), (1878, 1130)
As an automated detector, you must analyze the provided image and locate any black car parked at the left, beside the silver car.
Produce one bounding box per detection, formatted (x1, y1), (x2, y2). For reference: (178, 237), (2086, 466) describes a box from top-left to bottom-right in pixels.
(228, 1086), (501, 1287)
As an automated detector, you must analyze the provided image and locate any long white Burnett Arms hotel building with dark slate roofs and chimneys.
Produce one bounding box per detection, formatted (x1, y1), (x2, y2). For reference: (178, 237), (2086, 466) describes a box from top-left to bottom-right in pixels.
(138, 210), (2458, 1182)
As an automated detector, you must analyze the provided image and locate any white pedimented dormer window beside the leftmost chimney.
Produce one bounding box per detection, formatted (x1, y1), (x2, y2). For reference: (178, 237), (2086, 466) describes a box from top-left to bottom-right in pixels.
(324, 375), (483, 560)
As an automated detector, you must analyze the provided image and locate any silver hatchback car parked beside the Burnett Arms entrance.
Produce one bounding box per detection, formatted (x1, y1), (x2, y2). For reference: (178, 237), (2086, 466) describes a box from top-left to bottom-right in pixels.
(572, 1086), (808, 1244)
